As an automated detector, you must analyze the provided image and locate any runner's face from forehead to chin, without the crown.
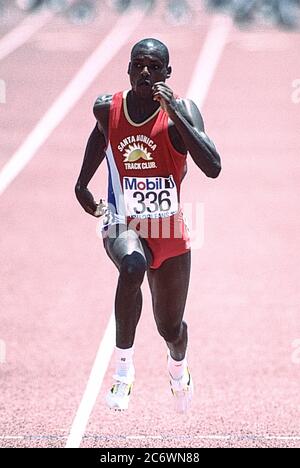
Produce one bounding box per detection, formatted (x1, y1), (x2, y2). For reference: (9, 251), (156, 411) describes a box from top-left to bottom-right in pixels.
(128, 47), (171, 98)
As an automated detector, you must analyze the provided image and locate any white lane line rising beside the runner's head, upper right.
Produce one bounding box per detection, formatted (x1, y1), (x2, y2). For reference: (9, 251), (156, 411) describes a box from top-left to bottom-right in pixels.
(187, 16), (232, 108)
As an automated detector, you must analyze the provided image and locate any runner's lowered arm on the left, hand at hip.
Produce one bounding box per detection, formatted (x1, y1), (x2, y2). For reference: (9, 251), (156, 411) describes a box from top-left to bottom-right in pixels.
(75, 96), (110, 218)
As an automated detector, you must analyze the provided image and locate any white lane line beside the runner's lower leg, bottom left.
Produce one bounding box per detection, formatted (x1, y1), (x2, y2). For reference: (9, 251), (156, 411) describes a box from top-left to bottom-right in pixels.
(66, 314), (115, 448)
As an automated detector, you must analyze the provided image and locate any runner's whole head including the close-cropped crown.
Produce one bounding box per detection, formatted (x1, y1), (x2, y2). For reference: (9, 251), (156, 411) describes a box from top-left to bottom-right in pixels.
(128, 38), (172, 97)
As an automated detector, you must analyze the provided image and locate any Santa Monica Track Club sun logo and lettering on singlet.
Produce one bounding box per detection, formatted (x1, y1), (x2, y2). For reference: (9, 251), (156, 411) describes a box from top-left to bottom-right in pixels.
(118, 135), (157, 170)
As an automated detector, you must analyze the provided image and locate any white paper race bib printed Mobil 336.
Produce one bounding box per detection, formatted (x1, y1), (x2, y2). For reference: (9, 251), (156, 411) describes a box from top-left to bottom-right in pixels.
(123, 175), (178, 219)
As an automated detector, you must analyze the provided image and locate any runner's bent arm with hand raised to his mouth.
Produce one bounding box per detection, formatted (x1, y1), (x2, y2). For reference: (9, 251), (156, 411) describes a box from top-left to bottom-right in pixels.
(153, 83), (221, 178)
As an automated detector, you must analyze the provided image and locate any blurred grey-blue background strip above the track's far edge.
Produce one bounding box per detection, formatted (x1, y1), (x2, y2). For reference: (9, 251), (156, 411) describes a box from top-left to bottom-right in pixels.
(0, 0), (300, 29)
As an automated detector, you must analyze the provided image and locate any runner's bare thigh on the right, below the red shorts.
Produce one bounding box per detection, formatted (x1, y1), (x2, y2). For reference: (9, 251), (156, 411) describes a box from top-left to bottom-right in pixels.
(148, 252), (191, 320)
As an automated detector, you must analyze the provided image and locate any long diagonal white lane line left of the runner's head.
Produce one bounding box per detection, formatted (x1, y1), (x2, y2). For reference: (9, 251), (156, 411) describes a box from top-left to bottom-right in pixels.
(0, 11), (146, 195)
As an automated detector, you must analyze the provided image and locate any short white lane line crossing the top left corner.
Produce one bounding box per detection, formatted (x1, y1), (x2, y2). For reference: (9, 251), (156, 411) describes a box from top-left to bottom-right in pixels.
(0, 11), (54, 60)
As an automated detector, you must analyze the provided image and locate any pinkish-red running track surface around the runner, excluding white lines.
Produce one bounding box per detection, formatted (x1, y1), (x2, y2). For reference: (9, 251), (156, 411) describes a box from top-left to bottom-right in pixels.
(0, 4), (300, 447)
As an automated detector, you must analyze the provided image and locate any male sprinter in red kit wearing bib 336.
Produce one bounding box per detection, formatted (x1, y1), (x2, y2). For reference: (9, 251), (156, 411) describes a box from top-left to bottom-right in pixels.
(76, 39), (221, 412)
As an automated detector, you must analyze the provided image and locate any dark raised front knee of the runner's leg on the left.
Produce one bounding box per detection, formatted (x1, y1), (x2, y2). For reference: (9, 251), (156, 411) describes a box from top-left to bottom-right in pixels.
(120, 252), (147, 287)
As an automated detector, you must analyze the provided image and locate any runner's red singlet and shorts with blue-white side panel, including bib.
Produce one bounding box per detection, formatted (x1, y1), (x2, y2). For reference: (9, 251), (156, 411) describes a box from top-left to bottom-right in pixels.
(103, 91), (190, 268)
